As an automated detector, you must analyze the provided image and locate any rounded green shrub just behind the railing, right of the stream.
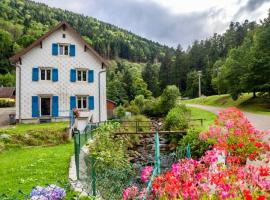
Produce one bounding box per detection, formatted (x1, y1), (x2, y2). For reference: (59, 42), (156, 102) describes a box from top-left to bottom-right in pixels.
(164, 105), (190, 130)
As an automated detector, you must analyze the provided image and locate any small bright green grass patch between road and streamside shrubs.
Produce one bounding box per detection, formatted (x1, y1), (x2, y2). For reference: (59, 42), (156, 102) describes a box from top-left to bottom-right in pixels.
(188, 107), (216, 130)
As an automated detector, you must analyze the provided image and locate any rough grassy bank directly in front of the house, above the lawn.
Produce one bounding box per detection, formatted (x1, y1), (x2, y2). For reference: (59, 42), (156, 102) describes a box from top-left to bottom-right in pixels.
(0, 122), (69, 151)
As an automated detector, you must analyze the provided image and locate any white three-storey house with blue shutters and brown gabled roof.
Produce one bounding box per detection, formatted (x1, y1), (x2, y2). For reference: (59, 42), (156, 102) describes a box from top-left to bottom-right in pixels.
(10, 22), (108, 122)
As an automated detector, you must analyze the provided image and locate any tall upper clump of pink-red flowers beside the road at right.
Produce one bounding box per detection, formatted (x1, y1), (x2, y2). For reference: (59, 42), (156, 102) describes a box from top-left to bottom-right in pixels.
(200, 108), (269, 164)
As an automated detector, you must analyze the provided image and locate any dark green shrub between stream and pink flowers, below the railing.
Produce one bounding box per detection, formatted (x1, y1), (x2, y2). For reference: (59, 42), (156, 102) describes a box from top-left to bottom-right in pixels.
(179, 128), (210, 159)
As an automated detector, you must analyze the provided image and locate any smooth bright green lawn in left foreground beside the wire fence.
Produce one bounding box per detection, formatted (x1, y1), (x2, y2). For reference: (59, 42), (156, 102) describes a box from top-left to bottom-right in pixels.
(0, 142), (73, 196)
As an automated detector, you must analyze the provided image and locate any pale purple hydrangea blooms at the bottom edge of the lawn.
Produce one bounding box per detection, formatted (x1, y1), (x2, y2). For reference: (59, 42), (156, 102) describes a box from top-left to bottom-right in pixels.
(30, 185), (66, 200)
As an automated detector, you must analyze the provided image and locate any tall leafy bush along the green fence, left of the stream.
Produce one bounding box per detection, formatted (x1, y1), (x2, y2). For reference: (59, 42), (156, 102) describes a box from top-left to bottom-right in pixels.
(89, 122), (134, 199)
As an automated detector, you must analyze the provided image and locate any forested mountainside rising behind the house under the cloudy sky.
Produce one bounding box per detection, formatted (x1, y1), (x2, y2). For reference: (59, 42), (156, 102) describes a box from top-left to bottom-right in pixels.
(0, 0), (173, 74)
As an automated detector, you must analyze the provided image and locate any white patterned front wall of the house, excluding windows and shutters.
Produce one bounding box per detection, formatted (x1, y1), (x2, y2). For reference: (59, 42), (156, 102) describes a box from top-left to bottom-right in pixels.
(16, 28), (107, 122)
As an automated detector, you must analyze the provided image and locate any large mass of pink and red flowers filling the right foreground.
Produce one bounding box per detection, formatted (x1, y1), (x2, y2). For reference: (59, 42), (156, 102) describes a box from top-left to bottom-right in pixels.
(123, 108), (270, 200)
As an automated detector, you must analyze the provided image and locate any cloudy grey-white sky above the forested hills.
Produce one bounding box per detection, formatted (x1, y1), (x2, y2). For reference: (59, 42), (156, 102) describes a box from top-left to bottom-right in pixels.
(35, 0), (270, 48)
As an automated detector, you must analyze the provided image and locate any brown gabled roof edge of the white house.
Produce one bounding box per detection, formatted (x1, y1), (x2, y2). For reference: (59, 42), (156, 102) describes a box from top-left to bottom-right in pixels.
(9, 21), (109, 67)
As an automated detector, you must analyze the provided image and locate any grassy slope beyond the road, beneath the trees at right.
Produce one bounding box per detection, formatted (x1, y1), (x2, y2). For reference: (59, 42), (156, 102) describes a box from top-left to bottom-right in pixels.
(181, 93), (270, 115)
